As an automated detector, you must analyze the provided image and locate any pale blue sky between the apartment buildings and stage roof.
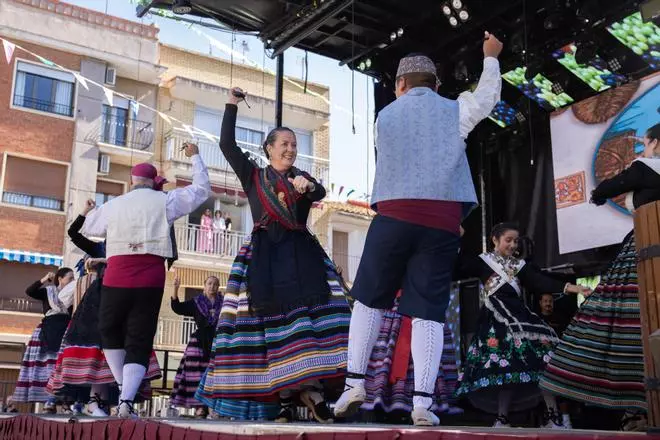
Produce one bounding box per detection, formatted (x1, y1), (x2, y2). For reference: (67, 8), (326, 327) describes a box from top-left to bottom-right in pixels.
(64, 0), (374, 198)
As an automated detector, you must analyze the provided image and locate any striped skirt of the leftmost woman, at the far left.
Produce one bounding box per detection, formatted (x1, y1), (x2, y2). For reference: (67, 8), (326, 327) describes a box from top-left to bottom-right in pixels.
(13, 324), (57, 402)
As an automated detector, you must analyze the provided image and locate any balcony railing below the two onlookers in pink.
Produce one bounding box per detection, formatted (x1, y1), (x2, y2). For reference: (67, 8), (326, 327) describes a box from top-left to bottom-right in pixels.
(174, 224), (250, 258)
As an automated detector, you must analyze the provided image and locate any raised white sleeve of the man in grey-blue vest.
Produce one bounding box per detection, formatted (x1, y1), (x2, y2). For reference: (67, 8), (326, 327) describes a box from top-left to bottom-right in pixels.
(458, 57), (502, 139)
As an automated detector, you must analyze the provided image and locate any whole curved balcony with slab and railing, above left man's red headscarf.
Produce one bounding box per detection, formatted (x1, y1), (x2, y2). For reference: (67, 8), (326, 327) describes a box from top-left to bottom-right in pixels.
(87, 113), (154, 166)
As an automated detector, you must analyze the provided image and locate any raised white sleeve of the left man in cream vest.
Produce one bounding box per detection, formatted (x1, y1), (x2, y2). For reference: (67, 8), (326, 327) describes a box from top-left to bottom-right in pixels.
(165, 154), (211, 225)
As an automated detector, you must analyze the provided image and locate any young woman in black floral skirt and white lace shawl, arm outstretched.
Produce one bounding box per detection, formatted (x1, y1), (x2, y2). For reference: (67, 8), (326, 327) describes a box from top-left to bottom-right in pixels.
(456, 223), (588, 428)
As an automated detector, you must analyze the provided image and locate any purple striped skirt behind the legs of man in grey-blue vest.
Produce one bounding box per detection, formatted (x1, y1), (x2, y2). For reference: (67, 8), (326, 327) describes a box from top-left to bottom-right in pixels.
(362, 306), (458, 413)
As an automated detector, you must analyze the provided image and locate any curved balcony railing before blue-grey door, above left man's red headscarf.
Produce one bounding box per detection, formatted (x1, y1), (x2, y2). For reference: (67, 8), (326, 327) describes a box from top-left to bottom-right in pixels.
(90, 114), (154, 151)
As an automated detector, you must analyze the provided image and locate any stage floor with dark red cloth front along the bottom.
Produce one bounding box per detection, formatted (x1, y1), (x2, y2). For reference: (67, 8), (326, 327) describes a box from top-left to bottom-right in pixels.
(0, 415), (660, 440)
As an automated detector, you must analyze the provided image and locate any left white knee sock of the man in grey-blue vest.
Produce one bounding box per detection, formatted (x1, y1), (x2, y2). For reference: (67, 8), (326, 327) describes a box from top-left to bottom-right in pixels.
(346, 301), (385, 387)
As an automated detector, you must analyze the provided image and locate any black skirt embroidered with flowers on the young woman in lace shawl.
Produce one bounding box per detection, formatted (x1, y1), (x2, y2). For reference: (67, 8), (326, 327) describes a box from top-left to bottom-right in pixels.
(456, 290), (558, 414)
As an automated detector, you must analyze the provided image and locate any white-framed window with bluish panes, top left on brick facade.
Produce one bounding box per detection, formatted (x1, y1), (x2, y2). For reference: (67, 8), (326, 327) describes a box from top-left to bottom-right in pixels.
(13, 61), (75, 116)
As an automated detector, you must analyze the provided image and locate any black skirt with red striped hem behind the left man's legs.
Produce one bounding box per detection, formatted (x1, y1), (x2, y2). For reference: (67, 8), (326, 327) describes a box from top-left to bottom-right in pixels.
(47, 281), (161, 402)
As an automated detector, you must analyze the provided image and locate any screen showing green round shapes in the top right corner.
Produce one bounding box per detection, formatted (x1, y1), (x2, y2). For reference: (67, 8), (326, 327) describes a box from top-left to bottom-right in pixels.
(607, 12), (660, 70)
